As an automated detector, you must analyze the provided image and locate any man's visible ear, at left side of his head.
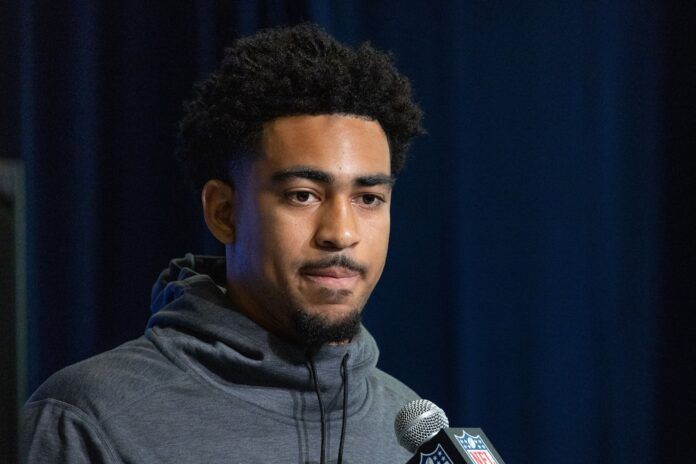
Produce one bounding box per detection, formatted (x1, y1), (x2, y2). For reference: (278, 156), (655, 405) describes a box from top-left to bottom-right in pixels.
(201, 179), (234, 245)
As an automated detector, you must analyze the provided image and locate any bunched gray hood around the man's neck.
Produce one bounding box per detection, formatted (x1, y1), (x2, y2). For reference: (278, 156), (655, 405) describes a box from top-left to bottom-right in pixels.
(145, 253), (379, 421)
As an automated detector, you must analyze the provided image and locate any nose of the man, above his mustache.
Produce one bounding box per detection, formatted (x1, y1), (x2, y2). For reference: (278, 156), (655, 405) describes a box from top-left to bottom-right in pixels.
(315, 198), (360, 250)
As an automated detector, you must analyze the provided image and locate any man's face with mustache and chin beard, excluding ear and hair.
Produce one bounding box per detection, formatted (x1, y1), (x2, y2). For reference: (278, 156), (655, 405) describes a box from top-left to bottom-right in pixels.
(228, 115), (392, 343)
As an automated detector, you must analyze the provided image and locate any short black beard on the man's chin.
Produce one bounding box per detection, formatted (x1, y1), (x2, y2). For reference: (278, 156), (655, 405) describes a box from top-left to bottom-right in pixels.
(292, 309), (361, 348)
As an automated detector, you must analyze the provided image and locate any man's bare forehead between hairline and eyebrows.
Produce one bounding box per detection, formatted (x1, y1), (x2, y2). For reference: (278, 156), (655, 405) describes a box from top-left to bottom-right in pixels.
(258, 114), (391, 178)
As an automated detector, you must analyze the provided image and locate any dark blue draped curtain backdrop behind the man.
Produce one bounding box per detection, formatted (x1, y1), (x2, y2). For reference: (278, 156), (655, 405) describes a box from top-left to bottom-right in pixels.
(0, 0), (696, 463)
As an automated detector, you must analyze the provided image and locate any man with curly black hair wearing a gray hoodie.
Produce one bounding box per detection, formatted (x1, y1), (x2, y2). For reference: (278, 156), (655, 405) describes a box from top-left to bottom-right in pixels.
(23, 24), (421, 463)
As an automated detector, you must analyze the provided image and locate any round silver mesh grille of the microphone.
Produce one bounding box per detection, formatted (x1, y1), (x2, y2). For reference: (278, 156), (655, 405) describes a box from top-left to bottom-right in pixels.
(394, 400), (449, 453)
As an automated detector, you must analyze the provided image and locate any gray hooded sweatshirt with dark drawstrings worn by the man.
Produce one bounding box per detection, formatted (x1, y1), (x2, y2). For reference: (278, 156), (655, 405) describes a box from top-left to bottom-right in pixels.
(22, 254), (417, 464)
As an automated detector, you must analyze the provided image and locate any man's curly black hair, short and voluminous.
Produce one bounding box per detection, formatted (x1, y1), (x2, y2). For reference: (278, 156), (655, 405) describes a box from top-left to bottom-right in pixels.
(176, 23), (423, 193)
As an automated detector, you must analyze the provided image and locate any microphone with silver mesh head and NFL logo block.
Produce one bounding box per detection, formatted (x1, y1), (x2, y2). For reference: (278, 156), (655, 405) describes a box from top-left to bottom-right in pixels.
(394, 399), (505, 464)
